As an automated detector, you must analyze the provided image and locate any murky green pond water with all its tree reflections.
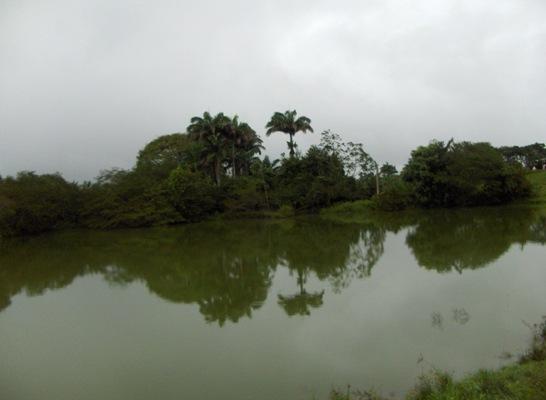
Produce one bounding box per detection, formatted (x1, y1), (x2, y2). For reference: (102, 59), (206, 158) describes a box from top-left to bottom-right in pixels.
(0, 208), (546, 400)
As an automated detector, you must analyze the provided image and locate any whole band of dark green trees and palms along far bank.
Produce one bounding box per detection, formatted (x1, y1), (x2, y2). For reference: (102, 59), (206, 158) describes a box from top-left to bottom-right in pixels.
(0, 111), (536, 236)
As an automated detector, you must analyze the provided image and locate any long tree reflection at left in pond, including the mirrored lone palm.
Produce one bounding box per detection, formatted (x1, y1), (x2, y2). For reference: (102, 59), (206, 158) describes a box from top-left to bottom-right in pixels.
(0, 219), (384, 325)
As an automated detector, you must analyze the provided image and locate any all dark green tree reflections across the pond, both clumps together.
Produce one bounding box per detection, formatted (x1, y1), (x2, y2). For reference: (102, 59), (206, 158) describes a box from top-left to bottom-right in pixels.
(0, 208), (546, 325)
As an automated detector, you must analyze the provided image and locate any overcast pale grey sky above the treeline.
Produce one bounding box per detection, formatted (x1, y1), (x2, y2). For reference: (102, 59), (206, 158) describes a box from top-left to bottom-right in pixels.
(0, 0), (546, 180)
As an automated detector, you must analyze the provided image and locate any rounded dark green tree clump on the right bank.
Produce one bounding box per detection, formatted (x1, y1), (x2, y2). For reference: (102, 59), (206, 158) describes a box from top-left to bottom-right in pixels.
(402, 141), (530, 207)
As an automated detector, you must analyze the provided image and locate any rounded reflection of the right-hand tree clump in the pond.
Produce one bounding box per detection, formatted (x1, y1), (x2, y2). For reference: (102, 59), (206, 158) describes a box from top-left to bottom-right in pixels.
(406, 207), (546, 273)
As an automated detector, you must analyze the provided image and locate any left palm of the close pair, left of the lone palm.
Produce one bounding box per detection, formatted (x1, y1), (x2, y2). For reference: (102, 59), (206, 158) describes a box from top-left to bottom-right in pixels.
(187, 112), (231, 185)
